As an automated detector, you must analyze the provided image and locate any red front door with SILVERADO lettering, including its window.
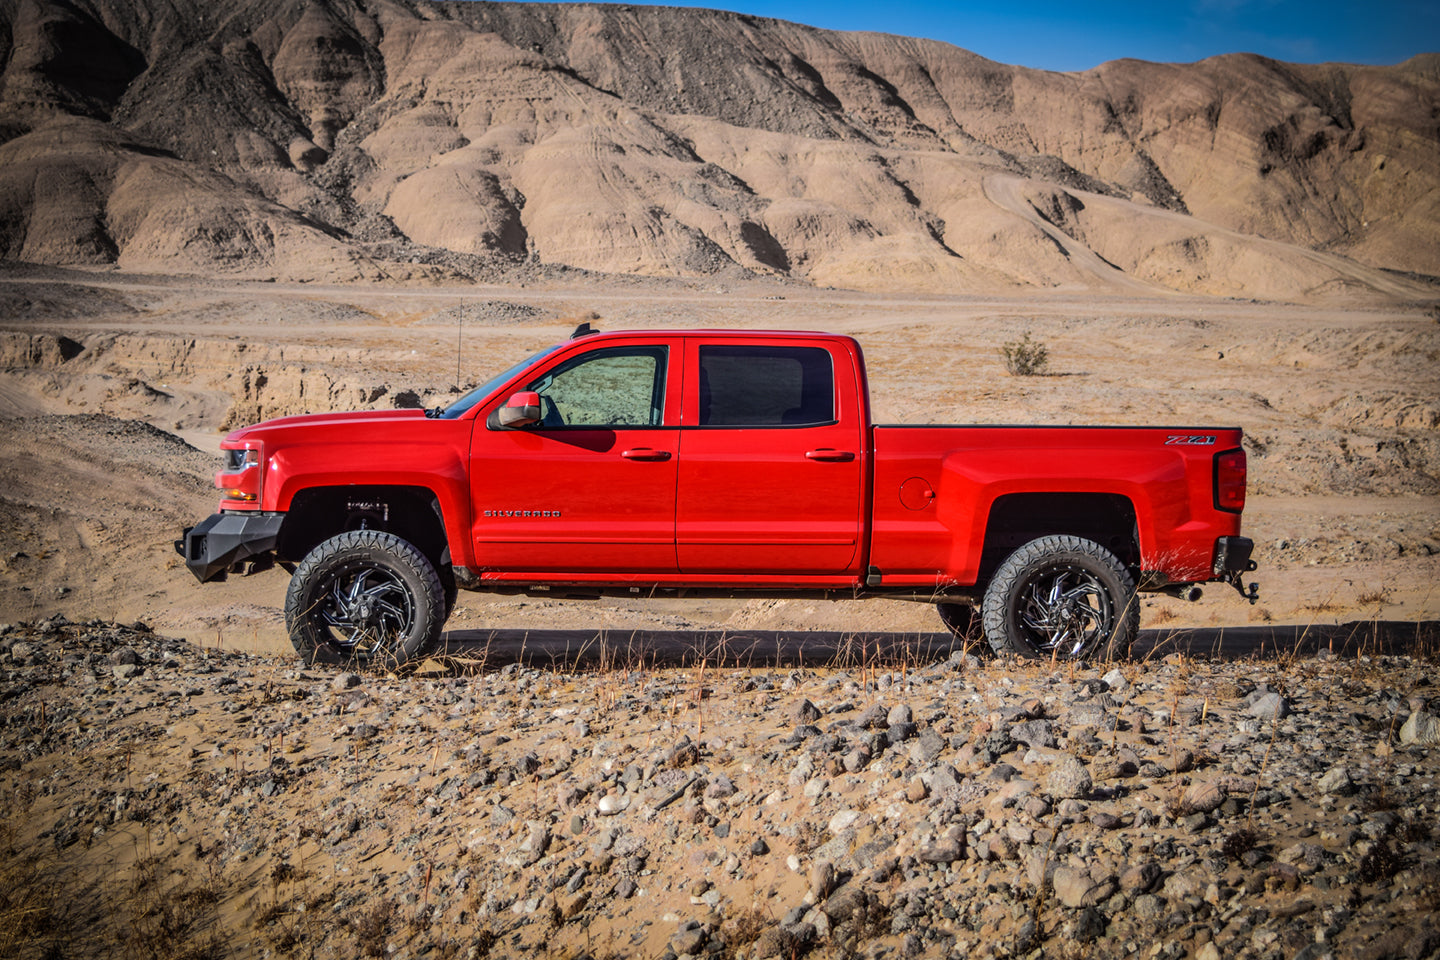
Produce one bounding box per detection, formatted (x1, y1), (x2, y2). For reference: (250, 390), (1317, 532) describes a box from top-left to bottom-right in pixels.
(469, 343), (680, 574)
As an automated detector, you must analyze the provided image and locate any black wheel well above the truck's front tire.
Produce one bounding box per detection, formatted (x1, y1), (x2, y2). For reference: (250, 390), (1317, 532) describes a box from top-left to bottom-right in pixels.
(276, 486), (451, 570)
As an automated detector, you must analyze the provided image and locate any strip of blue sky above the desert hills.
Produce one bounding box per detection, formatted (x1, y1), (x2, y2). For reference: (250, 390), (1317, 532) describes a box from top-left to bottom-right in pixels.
(567, 0), (1440, 71)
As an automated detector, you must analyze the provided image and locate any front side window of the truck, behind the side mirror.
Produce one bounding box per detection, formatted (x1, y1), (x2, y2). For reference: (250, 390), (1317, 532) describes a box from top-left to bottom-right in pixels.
(526, 347), (665, 427)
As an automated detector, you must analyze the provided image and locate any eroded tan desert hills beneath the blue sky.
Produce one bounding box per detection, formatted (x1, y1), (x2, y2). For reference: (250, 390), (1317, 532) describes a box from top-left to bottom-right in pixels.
(0, 0), (1440, 299)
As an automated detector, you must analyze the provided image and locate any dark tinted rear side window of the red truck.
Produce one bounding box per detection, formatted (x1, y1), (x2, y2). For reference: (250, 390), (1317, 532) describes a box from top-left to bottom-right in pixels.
(700, 345), (835, 426)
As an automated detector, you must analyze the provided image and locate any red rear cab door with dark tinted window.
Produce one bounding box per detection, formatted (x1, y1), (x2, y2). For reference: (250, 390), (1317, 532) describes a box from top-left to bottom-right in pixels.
(675, 337), (865, 576)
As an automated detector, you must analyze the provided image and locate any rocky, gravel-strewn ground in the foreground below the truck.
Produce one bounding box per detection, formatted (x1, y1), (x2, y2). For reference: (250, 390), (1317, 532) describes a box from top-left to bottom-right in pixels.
(0, 616), (1440, 960)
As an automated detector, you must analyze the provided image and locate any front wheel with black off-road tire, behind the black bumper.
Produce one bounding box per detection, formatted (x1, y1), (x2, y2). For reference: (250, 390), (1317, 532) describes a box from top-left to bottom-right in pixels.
(285, 530), (449, 666)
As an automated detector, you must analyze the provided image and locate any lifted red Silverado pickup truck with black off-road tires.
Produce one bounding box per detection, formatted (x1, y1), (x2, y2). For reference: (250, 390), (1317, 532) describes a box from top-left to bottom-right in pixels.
(176, 324), (1256, 662)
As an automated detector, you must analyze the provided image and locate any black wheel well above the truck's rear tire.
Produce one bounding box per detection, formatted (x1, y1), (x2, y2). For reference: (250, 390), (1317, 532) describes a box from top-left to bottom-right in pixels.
(979, 494), (1140, 583)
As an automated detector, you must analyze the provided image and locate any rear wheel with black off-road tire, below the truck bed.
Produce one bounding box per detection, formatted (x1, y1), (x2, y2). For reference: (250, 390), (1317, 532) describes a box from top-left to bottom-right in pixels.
(981, 537), (1140, 661)
